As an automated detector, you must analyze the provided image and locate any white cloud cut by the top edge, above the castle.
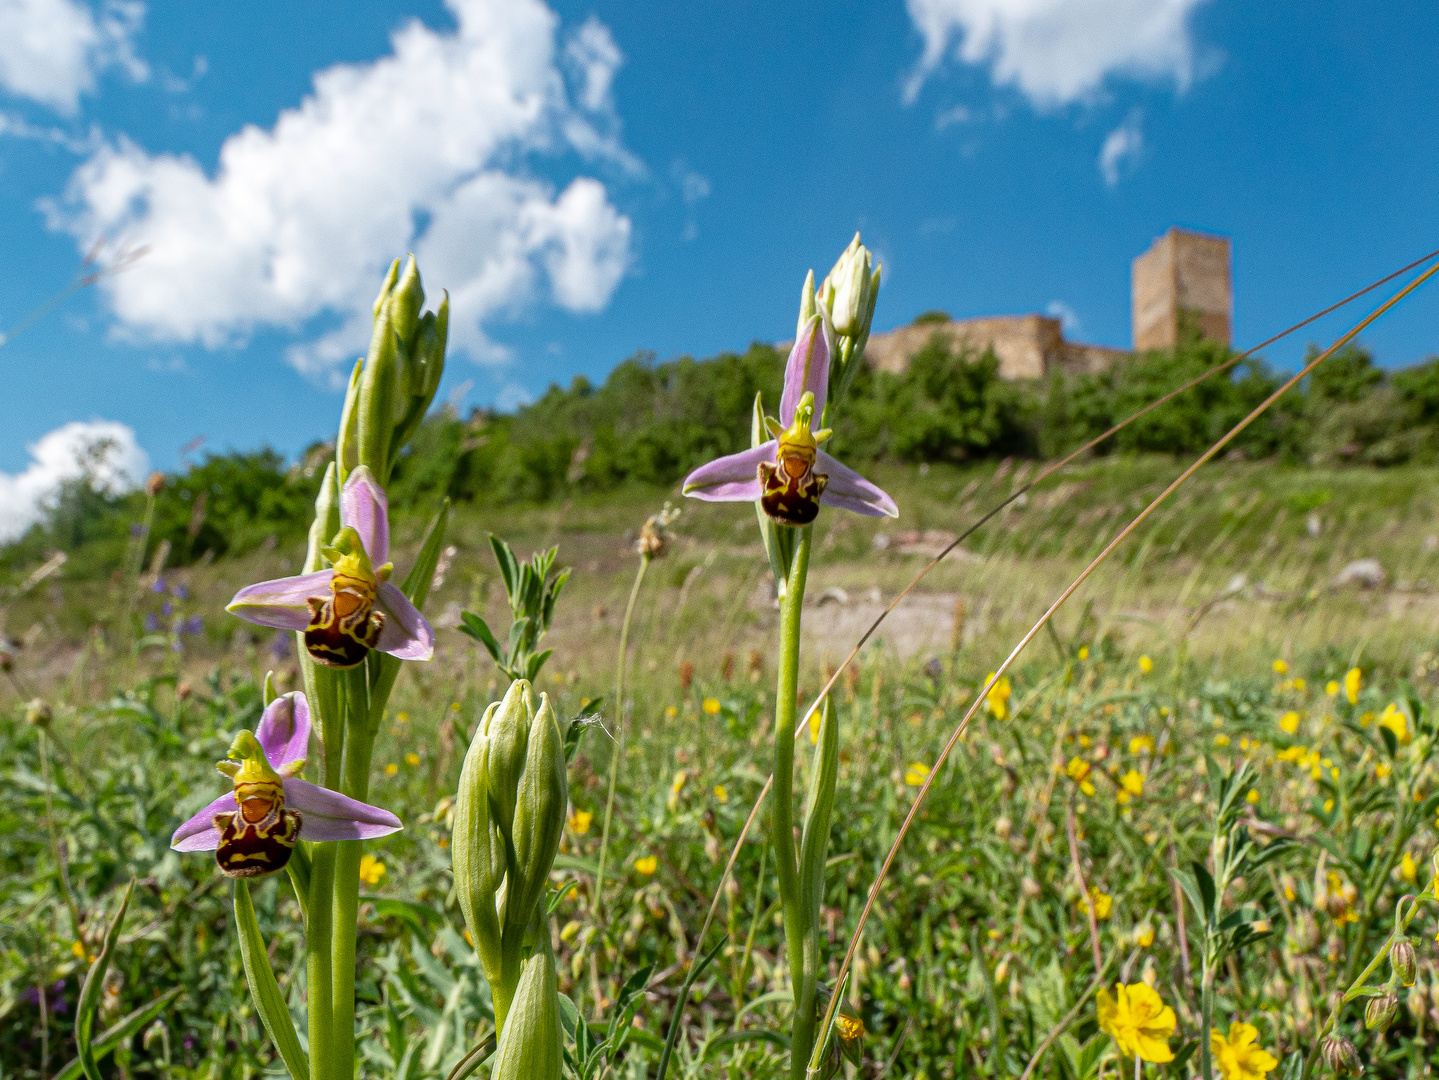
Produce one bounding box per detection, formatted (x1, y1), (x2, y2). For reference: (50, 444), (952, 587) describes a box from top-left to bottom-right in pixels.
(905, 0), (1203, 108)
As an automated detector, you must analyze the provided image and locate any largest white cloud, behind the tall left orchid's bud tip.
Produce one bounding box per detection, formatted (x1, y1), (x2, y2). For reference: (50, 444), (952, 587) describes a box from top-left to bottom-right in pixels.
(44, 0), (639, 378)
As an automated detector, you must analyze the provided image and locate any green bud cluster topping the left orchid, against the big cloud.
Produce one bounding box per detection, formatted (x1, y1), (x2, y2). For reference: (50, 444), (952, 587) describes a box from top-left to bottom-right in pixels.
(335, 255), (449, 486)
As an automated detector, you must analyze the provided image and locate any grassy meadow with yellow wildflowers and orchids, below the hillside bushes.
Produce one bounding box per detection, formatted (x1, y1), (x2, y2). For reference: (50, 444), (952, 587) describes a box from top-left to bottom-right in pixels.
(8, 234), (1439, 1080)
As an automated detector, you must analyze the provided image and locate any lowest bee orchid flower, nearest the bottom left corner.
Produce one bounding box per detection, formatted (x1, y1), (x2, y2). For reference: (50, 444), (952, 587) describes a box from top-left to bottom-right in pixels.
(170, 692), (403, 877)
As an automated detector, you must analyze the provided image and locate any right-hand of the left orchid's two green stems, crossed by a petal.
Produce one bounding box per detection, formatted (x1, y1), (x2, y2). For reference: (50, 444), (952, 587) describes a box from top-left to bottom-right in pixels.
(330, 664), (374, 1080)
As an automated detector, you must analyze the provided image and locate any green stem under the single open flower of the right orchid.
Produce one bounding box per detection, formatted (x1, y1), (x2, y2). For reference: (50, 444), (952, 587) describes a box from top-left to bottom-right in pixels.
(770, 525), (817, 1080)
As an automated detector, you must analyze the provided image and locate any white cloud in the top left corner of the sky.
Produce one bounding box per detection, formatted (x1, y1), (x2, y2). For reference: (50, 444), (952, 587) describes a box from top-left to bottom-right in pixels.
(0, 0), (150, 114)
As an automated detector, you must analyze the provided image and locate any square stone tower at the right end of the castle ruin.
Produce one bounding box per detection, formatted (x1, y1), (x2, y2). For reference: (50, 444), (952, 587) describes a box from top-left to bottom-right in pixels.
(1130, 229), (1235, 352)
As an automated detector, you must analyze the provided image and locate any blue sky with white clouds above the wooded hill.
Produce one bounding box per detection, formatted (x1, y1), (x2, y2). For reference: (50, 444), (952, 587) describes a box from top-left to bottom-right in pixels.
(0, 0), (1439, 532)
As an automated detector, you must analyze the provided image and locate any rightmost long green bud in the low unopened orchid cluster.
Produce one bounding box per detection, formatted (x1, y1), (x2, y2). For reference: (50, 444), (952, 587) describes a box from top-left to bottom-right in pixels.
(507, 695), (568, 925)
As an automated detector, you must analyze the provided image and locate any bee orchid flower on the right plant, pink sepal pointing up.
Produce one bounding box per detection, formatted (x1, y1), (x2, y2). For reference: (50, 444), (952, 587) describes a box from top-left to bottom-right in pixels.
(684, 315), (899, 525)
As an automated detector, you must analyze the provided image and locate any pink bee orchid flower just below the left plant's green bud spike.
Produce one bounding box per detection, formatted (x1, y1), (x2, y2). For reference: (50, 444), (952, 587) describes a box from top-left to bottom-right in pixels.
(226, 466), (435, 667)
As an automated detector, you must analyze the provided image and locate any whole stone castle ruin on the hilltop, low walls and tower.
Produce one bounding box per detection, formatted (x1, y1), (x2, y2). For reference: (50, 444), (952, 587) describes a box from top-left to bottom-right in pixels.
(865, 229), (1233, 378)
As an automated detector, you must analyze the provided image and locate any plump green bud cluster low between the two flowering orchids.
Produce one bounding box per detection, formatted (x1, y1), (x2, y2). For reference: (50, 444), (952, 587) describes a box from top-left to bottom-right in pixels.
(452, 679), (568, 1052)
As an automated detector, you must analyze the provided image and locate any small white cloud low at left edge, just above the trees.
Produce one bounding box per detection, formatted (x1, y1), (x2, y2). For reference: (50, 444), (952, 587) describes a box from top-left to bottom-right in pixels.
(0, 420), (150, 544)
